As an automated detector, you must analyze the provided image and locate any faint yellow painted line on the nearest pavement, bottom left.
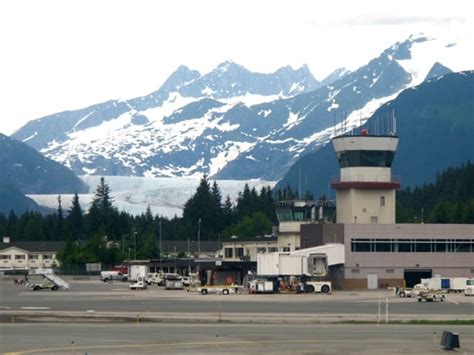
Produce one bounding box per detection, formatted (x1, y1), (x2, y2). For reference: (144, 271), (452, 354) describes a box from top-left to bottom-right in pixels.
(5, 339), (321, 355)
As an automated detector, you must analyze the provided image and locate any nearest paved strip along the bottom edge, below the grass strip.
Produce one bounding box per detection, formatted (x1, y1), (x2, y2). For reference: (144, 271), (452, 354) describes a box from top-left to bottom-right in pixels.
(0, 323), (474, 355)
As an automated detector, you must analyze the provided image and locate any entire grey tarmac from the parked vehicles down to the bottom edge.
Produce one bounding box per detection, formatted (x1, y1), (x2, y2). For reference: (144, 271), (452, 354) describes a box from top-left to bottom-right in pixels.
(0, 279), (474, 354)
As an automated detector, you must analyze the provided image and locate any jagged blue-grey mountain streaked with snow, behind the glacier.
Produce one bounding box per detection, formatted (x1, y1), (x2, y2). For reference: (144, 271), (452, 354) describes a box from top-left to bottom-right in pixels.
(14, 35), (471, 180)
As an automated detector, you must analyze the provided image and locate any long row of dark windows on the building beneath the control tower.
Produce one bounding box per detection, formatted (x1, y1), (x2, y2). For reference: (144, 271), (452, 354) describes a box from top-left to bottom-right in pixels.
(351, 239), (474, 253)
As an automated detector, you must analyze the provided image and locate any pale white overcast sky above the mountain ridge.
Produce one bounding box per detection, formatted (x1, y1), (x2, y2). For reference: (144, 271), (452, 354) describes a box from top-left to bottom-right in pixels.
(0, 0), (474, 135)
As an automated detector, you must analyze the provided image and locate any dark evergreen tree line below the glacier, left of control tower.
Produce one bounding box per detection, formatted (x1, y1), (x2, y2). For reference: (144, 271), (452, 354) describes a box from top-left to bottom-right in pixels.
(0, 176), (276, 266)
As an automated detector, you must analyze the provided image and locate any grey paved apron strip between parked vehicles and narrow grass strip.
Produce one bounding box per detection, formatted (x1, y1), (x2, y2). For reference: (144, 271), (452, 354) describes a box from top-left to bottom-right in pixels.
(0, 280), (474, 319)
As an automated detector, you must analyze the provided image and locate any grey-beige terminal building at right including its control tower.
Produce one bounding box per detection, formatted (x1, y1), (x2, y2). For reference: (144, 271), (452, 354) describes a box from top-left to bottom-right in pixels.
(292, 130), (474, 289)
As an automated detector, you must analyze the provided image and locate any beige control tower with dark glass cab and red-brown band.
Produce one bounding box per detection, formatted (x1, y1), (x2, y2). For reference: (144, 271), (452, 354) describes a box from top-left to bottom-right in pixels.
(331, 129), (400, 223)
